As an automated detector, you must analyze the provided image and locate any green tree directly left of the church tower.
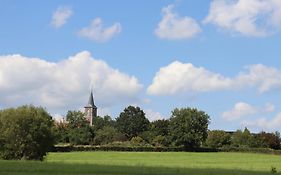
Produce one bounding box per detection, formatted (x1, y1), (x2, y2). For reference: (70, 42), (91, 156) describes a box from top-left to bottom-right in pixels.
(66, 111), (94, 145)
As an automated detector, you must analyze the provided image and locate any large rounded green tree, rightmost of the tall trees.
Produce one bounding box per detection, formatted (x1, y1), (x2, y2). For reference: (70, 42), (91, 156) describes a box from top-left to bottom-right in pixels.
(169, 108), (210, 149)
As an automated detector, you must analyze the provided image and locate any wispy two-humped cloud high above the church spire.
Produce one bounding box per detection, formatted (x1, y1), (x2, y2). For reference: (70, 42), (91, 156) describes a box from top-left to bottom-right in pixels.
(78, 18), (122, 42)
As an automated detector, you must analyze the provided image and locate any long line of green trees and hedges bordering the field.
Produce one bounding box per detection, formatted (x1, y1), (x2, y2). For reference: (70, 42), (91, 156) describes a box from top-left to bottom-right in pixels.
(0, 106), (280, 160)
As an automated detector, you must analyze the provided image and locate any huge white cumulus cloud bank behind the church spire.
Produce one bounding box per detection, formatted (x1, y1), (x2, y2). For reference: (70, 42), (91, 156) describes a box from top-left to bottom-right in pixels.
(0, 51), (142, 113)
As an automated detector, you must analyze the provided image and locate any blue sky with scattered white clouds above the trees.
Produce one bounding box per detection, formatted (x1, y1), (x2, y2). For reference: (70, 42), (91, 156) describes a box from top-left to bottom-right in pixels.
(0, 0), (281, 132)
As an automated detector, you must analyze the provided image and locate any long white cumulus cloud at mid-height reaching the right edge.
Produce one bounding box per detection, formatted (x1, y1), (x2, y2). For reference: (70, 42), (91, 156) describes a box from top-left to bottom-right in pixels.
(147, 61), (281, 95)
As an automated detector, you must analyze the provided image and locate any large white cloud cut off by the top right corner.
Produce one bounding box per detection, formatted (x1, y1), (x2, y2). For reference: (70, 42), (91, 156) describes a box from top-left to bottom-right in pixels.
(204, 0), (281, 37)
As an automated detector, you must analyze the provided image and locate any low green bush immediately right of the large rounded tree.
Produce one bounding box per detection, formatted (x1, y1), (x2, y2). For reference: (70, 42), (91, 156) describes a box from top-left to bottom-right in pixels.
(206, 130), (231, 148)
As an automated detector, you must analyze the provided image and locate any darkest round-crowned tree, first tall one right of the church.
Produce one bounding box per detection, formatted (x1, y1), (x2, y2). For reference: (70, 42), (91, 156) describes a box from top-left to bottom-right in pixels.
(116, 106), (149, 139)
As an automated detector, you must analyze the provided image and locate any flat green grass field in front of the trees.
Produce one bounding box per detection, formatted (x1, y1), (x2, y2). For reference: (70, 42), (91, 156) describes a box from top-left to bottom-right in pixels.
(0, 152), (281, 175)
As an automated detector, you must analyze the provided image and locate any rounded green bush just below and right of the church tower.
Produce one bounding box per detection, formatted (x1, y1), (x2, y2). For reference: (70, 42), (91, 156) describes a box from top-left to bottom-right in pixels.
(94, 126), (126, 145)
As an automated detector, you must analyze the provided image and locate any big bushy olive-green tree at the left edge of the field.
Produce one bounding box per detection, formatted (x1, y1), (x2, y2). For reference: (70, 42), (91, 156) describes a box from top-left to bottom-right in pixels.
(0, 106), (54, 160)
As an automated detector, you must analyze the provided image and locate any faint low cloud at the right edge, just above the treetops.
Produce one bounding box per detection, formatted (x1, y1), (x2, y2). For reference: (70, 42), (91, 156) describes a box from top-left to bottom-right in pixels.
(241, 113), (281, 131)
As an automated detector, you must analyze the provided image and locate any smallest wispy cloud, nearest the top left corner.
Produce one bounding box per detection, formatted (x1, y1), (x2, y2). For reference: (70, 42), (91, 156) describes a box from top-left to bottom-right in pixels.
(51, 7), (73, 28)
